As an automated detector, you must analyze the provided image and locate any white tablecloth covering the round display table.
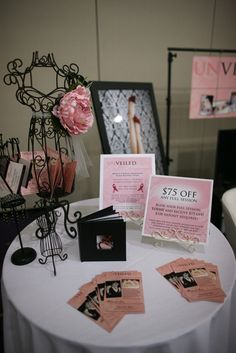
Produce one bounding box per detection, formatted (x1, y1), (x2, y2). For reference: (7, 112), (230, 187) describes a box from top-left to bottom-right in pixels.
(2, 199), (236, 353)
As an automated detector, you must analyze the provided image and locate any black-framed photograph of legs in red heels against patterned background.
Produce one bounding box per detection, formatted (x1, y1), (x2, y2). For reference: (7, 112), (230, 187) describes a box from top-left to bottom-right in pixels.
(91, 81), (166, 174)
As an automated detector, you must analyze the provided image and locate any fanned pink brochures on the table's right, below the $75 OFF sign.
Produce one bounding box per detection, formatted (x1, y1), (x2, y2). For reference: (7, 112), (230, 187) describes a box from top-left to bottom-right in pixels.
(156, 258), (225, 303)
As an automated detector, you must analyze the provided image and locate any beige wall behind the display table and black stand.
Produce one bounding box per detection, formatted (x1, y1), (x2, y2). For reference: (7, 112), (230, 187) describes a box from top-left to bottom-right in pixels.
(0, 0), (236, 205)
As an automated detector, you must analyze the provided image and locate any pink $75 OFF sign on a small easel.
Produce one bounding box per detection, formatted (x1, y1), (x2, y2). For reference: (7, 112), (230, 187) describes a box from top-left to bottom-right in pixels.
(142, 175), (213, 244)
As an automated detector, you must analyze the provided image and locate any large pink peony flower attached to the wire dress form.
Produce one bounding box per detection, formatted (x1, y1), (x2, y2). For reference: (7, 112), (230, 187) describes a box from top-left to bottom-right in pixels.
(52, 86), (94, 135)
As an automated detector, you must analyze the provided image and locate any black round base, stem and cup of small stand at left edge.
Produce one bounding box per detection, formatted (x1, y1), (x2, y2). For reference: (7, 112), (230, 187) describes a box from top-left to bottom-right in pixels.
(1, 194), (37, 266)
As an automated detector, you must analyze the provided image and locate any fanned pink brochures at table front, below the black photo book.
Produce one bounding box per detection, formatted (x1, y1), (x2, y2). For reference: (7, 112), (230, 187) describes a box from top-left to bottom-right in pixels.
(68, 271), (145, 332)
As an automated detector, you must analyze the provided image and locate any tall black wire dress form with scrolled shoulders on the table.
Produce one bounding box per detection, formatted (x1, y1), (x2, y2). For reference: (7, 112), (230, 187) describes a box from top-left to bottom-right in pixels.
(4, 52), (86, 274)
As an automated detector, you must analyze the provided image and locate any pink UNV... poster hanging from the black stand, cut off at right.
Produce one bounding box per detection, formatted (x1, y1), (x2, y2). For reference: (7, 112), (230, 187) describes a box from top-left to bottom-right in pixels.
(190, 56), (236, 119)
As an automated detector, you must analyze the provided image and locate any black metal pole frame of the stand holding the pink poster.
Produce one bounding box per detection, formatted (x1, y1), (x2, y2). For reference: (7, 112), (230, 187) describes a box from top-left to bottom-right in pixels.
(166, 48), (236, 174)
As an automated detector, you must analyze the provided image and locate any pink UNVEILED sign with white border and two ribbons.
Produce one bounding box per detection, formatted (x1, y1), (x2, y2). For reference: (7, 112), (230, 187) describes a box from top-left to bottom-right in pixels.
(99, 154), (155, 219)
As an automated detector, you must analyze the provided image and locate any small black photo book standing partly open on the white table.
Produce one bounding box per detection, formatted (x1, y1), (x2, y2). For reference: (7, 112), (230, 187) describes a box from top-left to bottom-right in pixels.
(77, 206), (126, 261)
